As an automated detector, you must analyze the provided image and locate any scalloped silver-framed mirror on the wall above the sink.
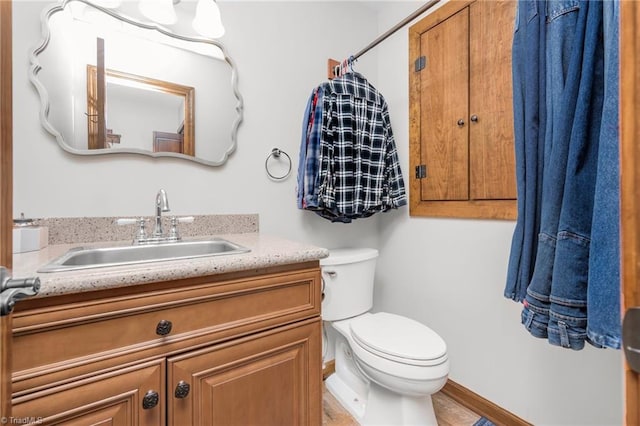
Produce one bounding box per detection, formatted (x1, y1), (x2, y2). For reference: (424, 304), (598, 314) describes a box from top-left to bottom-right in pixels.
(30, 0), (242, 166)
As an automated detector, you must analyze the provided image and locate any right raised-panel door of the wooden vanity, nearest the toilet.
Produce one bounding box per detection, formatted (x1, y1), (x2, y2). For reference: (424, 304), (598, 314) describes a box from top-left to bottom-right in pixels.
(167, 318), (322, 426)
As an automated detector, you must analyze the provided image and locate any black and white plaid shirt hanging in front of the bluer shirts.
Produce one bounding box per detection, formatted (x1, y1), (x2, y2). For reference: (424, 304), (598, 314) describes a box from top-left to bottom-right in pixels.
(318, 72), (407, 222)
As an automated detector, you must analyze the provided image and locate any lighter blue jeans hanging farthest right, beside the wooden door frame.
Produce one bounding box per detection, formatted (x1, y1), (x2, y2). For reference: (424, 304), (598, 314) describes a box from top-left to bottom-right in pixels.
(587, 0), (621, 349)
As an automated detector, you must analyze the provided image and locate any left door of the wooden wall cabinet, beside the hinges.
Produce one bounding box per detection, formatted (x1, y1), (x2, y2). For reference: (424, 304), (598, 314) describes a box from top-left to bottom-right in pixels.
(420, 8), (469, 200)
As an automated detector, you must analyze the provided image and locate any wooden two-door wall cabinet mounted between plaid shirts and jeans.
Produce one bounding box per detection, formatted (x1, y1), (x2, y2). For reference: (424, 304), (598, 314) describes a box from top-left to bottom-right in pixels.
(409, 0), (516, 219)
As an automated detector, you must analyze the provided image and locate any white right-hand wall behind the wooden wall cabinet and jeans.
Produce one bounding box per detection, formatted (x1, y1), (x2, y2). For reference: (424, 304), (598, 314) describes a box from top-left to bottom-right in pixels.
(374, 2), (623, 426)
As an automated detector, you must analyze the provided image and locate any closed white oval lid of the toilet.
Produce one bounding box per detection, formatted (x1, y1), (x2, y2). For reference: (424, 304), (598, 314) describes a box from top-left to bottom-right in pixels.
(350, 312), (447, 365)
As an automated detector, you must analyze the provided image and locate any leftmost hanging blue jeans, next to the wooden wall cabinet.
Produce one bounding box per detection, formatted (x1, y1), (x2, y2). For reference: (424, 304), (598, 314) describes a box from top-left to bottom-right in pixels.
(504, 0), (546, 302)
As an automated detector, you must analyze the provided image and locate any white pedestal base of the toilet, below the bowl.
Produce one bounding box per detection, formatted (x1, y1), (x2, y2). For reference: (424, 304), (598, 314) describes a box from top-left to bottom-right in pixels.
(325, 373), (438, 426)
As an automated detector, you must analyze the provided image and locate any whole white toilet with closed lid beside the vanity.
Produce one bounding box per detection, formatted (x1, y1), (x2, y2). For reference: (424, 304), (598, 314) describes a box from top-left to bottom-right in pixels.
(320, 249), (449, 426)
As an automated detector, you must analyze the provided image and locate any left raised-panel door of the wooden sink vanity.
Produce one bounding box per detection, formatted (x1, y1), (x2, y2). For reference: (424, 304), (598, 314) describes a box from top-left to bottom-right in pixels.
(10, 359), (166, 426)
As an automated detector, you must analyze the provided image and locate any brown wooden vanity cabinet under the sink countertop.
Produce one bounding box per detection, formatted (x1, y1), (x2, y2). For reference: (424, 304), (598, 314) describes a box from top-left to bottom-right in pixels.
(13, 262), (322, 426)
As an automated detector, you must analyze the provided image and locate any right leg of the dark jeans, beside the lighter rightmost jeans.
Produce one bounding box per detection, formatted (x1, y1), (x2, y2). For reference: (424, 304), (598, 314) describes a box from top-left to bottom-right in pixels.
(548, 1), (604, 349)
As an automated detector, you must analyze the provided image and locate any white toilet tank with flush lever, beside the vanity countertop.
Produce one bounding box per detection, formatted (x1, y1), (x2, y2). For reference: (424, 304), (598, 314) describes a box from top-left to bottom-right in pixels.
(320, 248), (378, 321)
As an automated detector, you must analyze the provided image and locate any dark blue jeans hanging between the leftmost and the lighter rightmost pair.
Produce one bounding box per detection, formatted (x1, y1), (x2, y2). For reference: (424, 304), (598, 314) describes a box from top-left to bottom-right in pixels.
(522, 0), (604, 349)
